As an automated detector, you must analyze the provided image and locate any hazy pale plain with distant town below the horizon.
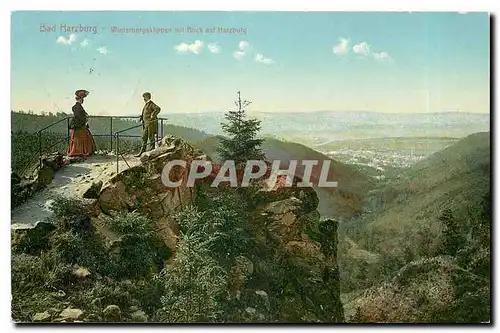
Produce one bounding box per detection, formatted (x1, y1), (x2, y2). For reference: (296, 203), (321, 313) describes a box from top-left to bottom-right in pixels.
(163, 111), (490, 171)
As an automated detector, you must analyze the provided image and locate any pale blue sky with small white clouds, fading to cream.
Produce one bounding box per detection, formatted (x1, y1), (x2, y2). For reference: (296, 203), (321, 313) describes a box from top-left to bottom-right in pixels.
(11, 11), (490, 115)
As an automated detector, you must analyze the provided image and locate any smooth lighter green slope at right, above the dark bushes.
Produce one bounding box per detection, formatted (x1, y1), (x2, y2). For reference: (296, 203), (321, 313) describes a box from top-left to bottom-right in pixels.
(343, 132), (491, 268)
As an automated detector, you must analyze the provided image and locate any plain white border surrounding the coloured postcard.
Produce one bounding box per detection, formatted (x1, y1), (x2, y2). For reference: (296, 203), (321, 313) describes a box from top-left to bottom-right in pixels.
(0, 0), (500, 331)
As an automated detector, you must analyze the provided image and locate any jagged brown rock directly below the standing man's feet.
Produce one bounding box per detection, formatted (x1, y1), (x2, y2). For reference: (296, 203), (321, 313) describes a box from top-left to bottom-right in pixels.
(97, 137), (198, 252)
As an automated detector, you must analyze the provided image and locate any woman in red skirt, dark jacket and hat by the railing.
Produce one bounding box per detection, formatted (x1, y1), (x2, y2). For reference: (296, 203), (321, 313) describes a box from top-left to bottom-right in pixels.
(68, 90), (95, 157)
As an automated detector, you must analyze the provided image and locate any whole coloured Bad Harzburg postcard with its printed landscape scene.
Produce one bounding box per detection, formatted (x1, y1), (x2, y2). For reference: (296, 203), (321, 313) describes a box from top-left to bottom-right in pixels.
(11, 11), (491, 324)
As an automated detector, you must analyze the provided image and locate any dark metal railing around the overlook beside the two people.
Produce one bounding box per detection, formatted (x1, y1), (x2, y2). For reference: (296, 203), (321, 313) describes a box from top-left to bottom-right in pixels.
(36, 116), (167, 173)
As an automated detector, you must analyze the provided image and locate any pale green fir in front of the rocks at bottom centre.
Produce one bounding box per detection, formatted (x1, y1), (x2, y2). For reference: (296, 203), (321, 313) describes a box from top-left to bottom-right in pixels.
(161, 207), (227, 322)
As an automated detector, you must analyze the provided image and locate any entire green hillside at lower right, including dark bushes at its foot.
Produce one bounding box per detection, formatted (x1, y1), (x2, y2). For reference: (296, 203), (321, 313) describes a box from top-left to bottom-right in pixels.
(339, 132), (491, 323)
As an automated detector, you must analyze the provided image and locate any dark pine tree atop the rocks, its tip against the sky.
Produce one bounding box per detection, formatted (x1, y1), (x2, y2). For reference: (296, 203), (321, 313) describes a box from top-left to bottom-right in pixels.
(217, 91), (264, 165)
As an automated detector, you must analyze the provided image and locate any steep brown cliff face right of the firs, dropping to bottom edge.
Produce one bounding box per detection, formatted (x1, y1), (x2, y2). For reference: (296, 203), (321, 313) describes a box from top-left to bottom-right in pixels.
(260, 196), (344, 322)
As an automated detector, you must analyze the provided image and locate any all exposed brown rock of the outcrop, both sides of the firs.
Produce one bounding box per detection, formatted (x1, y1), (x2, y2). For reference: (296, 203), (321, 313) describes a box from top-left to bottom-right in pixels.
(75, 137), (344, 322)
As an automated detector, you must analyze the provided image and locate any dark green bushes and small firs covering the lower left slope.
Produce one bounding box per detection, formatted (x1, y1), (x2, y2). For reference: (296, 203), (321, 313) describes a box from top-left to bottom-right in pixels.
(12, 199), (170, 321)
